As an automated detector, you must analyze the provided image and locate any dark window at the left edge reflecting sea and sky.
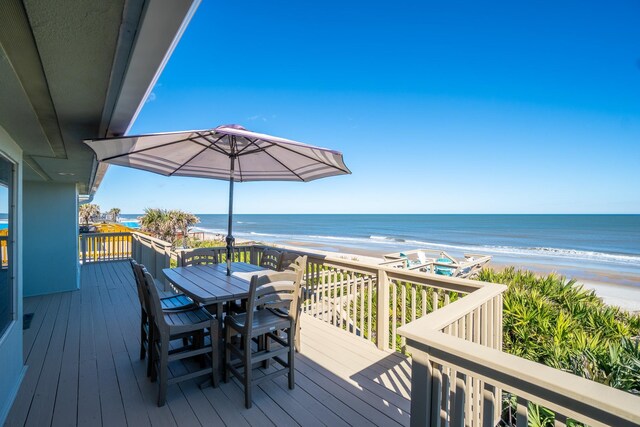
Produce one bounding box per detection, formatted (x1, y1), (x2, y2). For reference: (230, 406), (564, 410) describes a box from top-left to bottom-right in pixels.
(0, 156), (15, 337)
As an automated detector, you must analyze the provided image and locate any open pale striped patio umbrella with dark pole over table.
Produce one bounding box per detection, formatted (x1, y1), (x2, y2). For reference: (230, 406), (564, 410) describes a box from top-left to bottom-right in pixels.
(84, 125), (351, 275)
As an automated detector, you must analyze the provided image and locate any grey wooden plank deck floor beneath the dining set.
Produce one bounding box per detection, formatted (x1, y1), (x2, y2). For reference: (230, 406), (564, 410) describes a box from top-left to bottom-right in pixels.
(6, 262), (411, 427)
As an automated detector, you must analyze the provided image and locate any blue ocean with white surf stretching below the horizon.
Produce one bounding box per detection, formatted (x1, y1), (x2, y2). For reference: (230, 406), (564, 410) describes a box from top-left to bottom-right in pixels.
(123, 214), (640, 278)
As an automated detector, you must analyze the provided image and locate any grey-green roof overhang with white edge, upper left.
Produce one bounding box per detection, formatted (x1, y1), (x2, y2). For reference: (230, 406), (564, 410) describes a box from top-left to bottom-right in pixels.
(0, 0), (200, 198)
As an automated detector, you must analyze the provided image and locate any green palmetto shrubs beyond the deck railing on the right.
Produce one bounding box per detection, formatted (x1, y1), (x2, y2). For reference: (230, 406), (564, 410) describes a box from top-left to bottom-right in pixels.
(478, 267), (640, 426)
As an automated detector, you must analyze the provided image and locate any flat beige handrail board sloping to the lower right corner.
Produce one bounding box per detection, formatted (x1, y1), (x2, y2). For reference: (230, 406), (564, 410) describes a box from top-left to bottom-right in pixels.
(401, 328), (640, 425)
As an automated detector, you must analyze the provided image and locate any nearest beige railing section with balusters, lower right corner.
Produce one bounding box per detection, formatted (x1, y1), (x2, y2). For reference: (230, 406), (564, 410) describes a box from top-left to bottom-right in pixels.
(400, 306), (640, 427)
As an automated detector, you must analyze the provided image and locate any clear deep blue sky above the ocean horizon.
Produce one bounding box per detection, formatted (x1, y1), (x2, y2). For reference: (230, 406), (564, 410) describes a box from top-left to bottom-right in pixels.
(95, 1), (640, 213)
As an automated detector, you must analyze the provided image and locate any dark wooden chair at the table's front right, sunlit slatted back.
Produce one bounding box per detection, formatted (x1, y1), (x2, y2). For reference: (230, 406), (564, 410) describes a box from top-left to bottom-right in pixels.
(224, 270), (302, 409)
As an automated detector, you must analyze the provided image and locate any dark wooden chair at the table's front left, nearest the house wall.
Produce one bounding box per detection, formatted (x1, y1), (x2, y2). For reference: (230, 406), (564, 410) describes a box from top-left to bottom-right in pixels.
(143, 268), (218, 406)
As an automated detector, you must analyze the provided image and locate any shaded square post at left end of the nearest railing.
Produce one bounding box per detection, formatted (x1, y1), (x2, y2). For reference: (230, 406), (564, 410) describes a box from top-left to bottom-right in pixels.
(410, 349), (433, 427)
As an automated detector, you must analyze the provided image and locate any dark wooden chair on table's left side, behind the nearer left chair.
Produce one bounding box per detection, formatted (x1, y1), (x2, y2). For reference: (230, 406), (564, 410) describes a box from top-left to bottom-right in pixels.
(130, 259), (197, 376)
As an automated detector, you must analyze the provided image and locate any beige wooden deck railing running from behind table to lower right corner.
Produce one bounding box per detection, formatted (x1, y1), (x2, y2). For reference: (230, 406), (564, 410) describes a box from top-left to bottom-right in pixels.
(85, 239), (640, 426)
